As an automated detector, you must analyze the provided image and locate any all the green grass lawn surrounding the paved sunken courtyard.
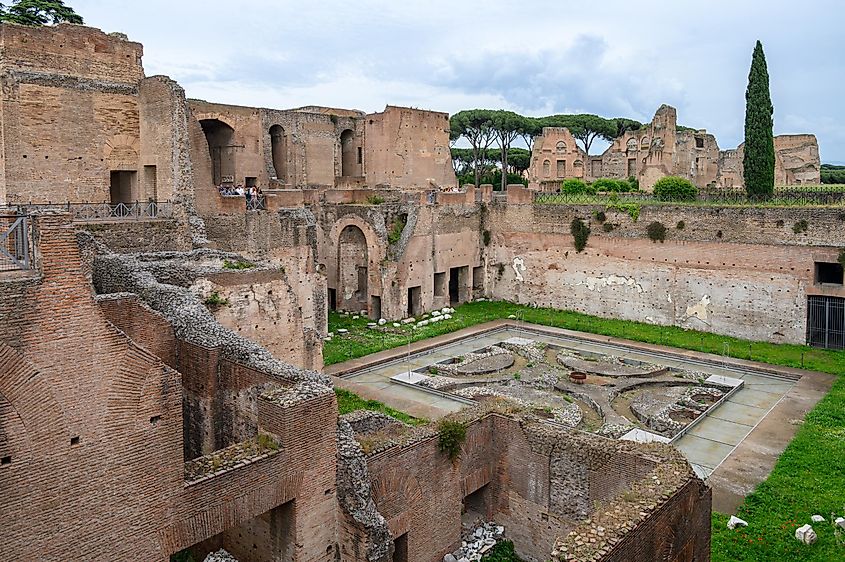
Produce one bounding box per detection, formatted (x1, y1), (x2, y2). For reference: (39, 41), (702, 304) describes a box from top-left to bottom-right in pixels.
(323, 302), (845, 562)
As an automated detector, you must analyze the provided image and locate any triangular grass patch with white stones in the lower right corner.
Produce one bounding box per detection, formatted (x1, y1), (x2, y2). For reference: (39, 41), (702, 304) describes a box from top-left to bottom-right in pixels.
(712, 378), (845, 562)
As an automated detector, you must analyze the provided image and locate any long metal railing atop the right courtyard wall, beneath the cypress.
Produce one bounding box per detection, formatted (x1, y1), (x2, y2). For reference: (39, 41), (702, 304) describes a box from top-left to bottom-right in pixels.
(534, 185), (845, 207)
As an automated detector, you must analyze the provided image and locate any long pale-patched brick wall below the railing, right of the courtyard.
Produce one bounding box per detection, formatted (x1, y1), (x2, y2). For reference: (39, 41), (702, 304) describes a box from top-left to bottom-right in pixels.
(487, 201), (845, 343)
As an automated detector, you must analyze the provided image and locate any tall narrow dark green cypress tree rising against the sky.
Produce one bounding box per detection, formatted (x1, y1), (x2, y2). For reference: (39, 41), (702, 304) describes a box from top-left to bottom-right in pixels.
(742, 41), (775, 197)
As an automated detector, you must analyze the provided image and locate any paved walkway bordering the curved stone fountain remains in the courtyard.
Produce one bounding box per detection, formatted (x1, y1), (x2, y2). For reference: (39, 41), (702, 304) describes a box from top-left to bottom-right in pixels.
(325, 320), (834, 512)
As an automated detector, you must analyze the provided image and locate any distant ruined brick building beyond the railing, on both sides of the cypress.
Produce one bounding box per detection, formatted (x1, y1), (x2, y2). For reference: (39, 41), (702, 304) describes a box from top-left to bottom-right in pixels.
(528, 105), (821, 190)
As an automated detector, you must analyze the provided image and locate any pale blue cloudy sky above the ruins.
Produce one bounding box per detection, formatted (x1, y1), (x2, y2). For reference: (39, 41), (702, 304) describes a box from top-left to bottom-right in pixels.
(76, 0), (845, 163)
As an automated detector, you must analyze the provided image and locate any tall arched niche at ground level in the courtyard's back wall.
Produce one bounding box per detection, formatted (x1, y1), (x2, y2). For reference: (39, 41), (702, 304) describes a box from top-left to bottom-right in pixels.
(337, 225), (369, 311)
